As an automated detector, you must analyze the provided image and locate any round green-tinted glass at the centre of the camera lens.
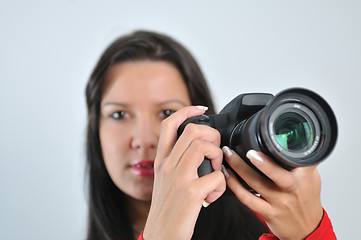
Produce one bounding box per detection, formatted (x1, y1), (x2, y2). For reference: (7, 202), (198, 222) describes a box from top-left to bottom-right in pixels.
(274, 112), (314, 152)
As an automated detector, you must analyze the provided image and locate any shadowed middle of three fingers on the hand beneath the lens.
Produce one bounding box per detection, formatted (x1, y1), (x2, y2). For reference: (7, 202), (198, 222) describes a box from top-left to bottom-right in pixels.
(222, 147), (275, 199)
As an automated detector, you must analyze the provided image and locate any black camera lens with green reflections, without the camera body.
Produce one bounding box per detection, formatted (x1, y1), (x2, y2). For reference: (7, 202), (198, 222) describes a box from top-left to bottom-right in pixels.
(230, 88), (337, 169)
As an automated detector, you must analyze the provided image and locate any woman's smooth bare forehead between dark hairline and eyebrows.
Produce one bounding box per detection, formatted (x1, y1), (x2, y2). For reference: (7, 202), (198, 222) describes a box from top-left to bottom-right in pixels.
(103, 61), (190, 104)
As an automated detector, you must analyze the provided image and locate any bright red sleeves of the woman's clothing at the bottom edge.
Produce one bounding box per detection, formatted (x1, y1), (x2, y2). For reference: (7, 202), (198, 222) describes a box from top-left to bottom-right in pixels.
(138, 210), (337, 240)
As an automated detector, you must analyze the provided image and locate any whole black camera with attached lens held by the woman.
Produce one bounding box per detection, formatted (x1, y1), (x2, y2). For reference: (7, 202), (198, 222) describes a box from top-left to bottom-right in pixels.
(178, 88), (337, 176)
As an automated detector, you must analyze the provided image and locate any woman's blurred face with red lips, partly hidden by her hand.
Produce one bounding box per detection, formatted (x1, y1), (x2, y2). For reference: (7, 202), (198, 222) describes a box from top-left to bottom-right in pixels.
(99, 61), (191, 200)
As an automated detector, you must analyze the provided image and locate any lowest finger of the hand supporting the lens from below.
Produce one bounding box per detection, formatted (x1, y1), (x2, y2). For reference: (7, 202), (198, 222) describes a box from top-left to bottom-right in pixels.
(226, 170), (272, 216)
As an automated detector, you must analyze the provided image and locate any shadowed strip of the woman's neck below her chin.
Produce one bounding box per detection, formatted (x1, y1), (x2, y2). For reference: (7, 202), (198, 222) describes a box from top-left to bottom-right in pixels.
(127, 196), (150, 231)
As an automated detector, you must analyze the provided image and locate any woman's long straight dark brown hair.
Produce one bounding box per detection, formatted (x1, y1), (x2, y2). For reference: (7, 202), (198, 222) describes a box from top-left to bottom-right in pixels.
(86, 31), (263, 240)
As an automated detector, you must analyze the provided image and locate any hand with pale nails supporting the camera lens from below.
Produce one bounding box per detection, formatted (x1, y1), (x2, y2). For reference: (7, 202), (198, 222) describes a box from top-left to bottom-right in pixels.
(223, 147), (323, 239)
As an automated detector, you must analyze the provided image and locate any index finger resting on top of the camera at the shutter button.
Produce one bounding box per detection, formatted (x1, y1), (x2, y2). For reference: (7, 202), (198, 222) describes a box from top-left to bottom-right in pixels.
(154, 106), (207, 167)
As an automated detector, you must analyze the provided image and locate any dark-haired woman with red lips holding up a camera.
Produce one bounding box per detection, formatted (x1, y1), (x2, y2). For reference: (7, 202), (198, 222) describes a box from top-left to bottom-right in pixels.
(86, 31), (334, 240)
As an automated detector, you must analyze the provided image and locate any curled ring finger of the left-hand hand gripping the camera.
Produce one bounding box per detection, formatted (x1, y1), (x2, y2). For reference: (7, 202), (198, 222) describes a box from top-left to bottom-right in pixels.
(176, 139), (223, 177)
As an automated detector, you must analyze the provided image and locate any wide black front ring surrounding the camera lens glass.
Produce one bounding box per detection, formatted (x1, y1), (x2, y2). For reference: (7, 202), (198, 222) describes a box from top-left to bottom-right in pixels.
(260, 88), (337, 169)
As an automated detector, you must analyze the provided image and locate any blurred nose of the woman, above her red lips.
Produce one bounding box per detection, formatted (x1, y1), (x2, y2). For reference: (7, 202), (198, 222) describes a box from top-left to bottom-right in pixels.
(131, 116), (160, 151)
